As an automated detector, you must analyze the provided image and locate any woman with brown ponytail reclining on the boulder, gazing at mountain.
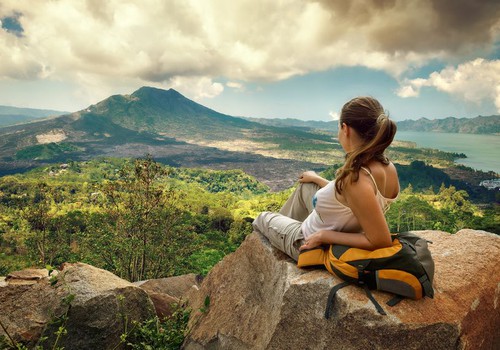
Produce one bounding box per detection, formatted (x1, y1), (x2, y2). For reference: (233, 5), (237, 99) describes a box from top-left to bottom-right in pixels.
(253, 97), (399, 261)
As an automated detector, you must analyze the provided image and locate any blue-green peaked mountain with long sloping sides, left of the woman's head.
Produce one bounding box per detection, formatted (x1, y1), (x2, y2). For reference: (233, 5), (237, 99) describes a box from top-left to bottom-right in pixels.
(0, 87), (340, 188)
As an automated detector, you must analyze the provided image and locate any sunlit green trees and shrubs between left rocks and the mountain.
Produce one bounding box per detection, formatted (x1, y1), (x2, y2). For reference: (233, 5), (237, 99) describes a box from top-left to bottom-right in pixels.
(0, 159), (267, 280)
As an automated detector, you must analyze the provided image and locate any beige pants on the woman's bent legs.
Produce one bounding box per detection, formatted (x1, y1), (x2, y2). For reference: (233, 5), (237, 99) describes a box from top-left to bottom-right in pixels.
(253, 183), (320, 261)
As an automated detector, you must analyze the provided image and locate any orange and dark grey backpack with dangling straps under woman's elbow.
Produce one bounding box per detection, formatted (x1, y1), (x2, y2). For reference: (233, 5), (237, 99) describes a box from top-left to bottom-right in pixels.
(297, 232), (434, 319)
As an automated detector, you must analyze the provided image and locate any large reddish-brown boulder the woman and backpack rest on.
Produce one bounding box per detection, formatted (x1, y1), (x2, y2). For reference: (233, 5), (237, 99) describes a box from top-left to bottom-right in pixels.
(183, 230), (500, 350)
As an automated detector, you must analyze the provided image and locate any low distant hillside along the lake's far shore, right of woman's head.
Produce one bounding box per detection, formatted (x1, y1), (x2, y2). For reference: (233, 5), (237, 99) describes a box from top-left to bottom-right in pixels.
(397, 115), (500, 134)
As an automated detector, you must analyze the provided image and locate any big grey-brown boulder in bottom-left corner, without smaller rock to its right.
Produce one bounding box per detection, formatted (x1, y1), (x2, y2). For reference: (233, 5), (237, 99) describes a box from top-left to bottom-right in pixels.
(0, 263), (154, 349)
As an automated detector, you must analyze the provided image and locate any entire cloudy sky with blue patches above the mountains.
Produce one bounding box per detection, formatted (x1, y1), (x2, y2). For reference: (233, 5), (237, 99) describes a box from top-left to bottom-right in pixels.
(0, 0), (500, 120)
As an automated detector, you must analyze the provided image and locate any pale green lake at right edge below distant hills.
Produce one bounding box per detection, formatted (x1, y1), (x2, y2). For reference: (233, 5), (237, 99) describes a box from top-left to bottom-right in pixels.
(395, 131), (500, 173)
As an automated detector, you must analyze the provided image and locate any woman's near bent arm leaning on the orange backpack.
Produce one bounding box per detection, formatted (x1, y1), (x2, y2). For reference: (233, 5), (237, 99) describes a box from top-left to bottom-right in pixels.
(300, 176), (392, 250)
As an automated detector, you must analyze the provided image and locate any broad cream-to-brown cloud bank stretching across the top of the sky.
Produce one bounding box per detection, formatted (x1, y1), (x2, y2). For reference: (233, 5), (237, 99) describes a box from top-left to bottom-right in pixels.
(0, 0), (500, 106)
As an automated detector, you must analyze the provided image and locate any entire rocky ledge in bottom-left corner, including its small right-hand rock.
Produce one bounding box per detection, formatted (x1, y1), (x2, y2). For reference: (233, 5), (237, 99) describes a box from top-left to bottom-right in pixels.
(0, 263), (200, 350)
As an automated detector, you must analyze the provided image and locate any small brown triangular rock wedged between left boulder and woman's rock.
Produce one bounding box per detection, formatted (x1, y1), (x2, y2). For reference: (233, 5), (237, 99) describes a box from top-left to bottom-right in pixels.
(134, 273), (201, 318)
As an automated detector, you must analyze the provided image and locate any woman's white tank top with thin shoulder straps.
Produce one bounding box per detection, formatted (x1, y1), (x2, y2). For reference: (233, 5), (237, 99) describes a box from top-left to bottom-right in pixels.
(301, 168), (399, 238)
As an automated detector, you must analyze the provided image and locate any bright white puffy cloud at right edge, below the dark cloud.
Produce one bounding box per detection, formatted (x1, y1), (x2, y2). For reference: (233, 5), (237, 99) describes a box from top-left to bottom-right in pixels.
(397, 58), (500, 112)
